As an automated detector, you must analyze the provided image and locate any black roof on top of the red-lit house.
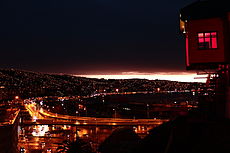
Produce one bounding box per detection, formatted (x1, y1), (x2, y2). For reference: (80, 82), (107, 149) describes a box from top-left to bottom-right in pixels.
(180, 0), (230, 21)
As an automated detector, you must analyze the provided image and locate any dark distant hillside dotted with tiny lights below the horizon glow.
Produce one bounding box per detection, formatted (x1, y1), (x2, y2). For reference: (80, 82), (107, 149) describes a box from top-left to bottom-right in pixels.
(0, 69), (205, 100)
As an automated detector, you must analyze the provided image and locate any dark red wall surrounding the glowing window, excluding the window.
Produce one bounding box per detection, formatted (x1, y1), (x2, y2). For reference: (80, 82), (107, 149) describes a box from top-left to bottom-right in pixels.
(186, 18), (225, 64)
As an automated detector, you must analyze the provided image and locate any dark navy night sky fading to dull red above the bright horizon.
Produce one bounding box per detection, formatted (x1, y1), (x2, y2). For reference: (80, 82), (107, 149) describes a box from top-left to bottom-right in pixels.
(0, 0), (194, 74)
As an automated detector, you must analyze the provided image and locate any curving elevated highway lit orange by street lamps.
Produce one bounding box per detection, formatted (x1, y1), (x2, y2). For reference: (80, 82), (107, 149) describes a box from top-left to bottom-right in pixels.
(24, 103), (168, 126)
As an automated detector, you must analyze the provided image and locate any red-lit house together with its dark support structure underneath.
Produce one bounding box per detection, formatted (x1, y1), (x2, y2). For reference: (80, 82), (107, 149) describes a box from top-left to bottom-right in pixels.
(180, 0), (230, 118)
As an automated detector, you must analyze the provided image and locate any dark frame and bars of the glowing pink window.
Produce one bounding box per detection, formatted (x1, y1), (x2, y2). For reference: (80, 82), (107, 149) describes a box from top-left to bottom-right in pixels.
(196, 31), (219, 50)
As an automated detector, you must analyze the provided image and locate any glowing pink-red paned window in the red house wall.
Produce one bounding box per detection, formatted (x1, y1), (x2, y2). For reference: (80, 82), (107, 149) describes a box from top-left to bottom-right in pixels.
(198, 32), (217, 49)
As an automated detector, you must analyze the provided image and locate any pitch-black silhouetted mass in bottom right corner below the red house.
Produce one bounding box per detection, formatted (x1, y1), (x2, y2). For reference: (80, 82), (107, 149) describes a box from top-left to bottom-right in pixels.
(134, 114), (230, 153)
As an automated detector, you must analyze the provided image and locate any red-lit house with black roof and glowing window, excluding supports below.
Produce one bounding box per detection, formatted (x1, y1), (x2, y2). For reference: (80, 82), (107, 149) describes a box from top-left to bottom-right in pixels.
(180, 0), (230, 70)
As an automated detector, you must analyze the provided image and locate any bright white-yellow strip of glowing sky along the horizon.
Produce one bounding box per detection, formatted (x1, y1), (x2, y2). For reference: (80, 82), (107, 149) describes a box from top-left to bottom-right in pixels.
(75, 72), (207, 83)
